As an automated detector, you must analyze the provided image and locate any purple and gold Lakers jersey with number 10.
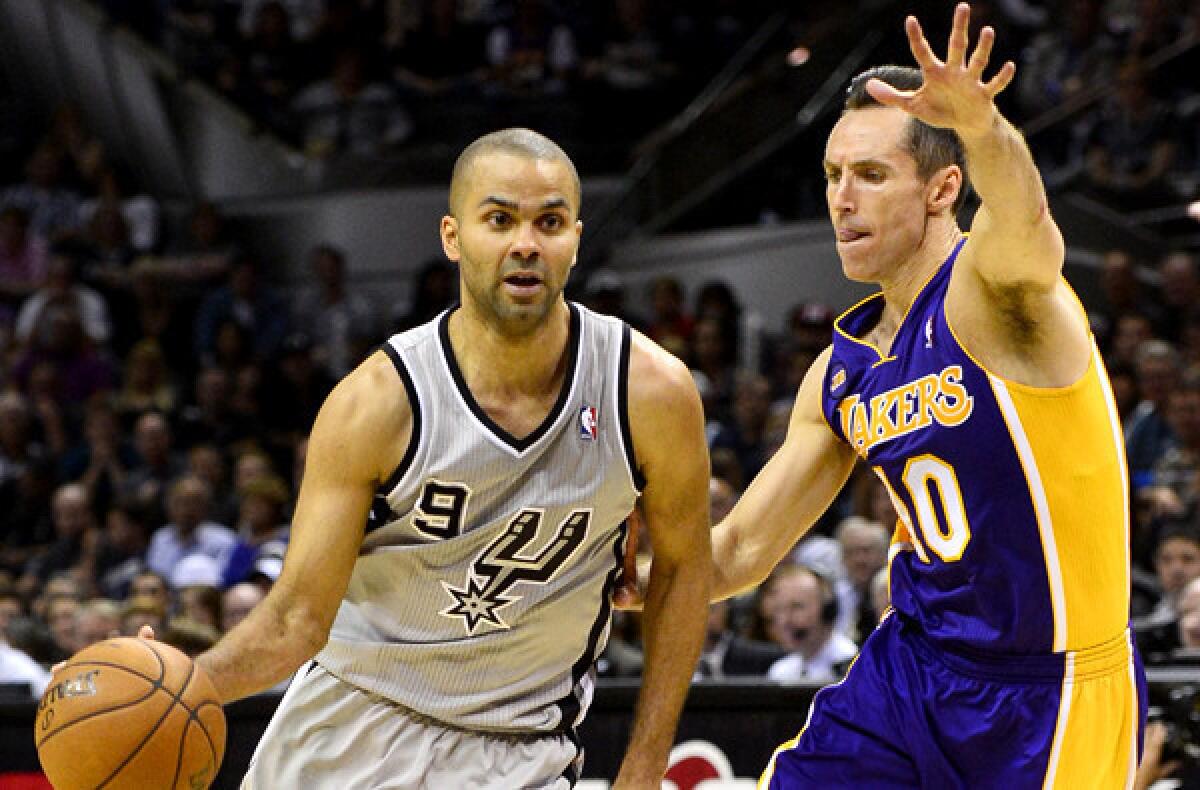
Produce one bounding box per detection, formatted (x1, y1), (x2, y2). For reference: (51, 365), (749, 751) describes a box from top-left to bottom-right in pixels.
(822, 243), (1129, 654)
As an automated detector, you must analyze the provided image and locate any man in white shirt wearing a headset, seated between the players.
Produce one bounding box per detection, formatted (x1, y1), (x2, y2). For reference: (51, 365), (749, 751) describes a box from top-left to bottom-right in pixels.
(767, 564), (858, 683)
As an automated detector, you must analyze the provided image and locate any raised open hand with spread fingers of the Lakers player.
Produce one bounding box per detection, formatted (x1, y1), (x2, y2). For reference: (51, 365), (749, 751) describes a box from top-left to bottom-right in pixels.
(866, 2), (1016, 138)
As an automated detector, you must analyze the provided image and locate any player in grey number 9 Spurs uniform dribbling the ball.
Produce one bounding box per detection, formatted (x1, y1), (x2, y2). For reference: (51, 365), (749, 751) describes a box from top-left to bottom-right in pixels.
(190, 130), (710, 790)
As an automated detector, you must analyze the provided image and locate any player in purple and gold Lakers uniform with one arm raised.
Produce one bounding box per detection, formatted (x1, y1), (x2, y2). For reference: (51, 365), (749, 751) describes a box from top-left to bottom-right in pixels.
(713, 4), (1145, 789)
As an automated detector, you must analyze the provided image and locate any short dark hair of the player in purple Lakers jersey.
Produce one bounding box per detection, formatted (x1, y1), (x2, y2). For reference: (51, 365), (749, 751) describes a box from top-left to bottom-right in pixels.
(841, 65), (971, 213)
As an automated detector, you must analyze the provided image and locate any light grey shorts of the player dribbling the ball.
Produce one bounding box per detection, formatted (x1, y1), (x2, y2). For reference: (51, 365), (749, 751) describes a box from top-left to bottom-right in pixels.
(241, 663), (582, 790)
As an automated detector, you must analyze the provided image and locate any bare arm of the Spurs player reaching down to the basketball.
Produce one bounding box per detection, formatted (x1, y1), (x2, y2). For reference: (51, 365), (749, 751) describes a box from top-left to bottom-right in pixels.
(197, 353), (412, 702)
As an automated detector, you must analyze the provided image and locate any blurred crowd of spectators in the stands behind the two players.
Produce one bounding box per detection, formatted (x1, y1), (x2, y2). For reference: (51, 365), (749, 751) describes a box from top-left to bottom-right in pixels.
(0, 0), (1200, 693)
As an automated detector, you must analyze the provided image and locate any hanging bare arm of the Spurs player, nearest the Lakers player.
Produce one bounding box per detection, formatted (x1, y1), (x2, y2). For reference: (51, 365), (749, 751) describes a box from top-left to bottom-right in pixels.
(613, 334), (712, 788)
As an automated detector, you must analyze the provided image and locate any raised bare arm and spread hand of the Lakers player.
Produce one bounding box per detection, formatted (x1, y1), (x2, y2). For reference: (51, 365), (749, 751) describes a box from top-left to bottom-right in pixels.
(866, 2), (1091, 376)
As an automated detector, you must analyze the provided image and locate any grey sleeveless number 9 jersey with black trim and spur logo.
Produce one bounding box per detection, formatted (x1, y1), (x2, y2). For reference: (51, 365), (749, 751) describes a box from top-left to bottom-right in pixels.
(317, 304), (638, 732)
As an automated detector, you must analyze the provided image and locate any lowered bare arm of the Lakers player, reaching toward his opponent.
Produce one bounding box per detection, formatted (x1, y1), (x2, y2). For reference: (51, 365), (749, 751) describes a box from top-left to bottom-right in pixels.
(713, 348), (854, 599)
